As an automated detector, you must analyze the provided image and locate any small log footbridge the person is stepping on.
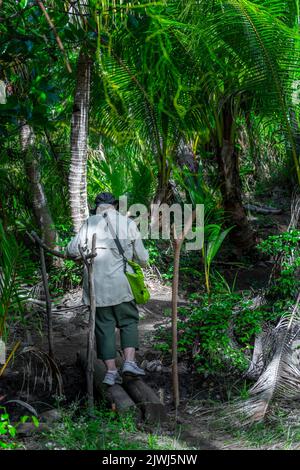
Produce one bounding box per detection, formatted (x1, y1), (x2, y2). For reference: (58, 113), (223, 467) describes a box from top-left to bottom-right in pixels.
(77, 351), (167, 424)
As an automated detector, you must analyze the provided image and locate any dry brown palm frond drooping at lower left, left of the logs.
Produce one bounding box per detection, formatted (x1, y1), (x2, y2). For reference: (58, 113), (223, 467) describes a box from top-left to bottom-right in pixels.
(20, 346), (63, 395)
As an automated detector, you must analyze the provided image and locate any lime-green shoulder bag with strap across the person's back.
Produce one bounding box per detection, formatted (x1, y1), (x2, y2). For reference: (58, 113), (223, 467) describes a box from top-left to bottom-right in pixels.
(103, 213), (150, 304)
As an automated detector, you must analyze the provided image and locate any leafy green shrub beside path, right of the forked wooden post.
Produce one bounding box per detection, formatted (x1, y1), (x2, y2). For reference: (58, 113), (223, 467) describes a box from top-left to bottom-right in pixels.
(156, 292), (279, 373)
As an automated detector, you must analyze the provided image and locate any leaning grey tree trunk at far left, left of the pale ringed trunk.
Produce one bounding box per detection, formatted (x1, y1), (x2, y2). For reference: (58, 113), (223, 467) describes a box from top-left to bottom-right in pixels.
(20, 124), (58, 248)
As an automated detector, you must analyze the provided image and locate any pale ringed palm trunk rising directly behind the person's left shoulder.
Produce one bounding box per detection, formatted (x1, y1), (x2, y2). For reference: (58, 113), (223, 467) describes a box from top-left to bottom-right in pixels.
(69, 52), (91, 233)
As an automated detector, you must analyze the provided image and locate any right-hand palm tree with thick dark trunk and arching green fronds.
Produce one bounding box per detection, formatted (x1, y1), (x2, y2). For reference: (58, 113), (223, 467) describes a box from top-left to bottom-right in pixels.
(181, 0), (300, 250)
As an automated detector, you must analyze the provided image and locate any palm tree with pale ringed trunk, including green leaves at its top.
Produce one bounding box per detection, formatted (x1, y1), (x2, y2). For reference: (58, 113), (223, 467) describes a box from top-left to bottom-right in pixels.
(68, 0), (161, 232)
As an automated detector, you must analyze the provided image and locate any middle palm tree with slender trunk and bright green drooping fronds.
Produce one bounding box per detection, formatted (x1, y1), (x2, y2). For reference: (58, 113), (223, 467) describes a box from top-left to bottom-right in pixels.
(93, 2), (196, 208)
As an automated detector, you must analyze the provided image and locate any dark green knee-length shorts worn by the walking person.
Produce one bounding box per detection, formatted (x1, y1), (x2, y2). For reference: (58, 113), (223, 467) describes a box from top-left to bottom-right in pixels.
(95, 300), (139, 361)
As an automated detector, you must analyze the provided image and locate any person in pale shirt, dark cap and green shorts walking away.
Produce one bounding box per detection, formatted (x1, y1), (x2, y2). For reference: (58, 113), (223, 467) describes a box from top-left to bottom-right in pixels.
(67, 193), (149, 385)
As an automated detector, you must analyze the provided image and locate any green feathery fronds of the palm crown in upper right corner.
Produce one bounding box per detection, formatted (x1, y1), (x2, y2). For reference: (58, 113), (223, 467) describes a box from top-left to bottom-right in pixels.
(180, 0), (300, 178)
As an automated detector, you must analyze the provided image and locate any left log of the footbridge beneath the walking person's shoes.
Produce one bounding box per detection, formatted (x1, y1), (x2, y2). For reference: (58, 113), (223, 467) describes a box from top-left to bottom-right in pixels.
(77, 351), (141, 418)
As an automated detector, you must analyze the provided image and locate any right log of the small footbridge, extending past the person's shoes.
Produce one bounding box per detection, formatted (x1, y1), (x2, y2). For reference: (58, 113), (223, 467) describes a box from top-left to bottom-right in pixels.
(123, 374), (167, 424)
